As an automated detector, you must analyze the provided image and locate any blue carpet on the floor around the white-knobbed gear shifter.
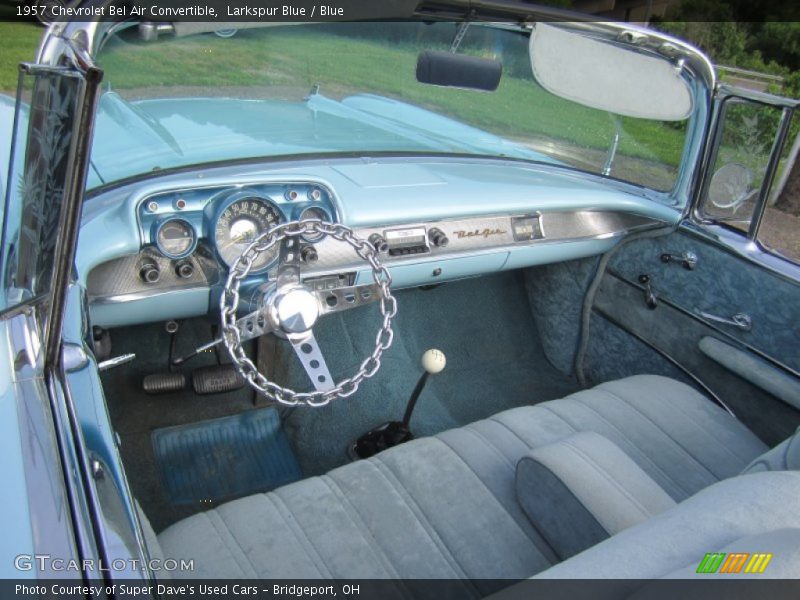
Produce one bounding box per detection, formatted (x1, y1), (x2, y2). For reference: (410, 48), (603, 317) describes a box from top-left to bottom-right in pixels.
(281, 272), (578, 476)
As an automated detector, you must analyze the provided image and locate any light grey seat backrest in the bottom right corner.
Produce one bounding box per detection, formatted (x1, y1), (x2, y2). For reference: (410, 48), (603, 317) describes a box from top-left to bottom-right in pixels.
(538, 471), (800, 579)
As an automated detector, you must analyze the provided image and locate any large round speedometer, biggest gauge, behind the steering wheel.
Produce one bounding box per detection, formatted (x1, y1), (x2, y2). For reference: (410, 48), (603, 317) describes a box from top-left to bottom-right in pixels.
(214, 197), (281, 272)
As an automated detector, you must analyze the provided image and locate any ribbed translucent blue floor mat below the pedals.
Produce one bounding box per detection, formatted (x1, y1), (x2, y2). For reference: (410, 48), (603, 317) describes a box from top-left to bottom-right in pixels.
(153, 408), (302, 504)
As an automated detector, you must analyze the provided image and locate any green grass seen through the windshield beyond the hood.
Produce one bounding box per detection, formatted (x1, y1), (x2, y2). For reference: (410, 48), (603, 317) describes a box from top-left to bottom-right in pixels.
(101, 27), (684, 173)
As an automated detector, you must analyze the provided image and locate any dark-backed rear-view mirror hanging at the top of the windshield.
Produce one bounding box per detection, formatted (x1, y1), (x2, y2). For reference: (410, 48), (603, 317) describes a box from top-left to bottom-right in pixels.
(417, 50), (503, 92)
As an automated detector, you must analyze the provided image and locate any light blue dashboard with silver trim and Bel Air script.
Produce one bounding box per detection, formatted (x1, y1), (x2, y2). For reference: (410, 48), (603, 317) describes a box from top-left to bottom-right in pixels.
(77, 159), (678, 327)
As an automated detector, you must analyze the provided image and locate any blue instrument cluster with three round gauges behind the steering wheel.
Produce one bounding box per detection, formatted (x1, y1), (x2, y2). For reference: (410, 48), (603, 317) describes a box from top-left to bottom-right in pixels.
(139, 182), (337, 283)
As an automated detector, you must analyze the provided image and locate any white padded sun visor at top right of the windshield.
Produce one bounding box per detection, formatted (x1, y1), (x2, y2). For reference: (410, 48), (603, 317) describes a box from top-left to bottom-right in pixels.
(529, 23), (693, 121)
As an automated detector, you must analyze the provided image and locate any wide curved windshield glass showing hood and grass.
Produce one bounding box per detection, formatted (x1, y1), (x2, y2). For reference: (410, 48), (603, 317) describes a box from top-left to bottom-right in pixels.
(91, 22), (686, 190)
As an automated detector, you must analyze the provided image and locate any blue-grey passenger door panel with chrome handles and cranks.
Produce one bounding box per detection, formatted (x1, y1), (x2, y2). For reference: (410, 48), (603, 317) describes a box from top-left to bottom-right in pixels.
(586, 226), (800, 444)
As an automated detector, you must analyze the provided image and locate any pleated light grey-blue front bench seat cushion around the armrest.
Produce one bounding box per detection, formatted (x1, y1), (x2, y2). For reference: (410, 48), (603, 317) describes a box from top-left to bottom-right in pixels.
(158, 376), (767, 596)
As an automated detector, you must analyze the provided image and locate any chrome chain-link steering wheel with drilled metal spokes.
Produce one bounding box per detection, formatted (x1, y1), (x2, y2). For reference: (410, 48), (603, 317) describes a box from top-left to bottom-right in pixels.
(220, 219), (397, 406)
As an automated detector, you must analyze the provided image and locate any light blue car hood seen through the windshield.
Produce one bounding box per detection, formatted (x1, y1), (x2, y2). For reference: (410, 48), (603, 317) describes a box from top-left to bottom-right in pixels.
(88, 92), (557, 188)
